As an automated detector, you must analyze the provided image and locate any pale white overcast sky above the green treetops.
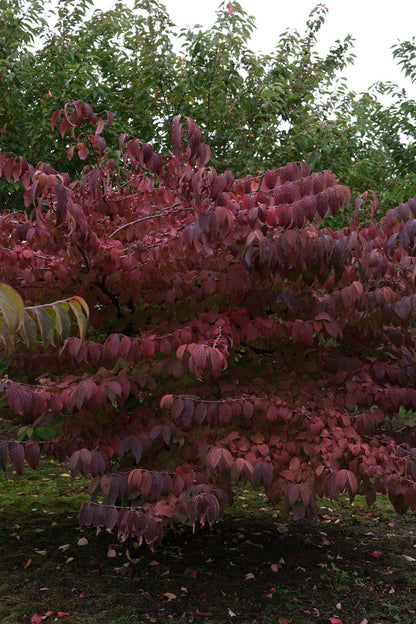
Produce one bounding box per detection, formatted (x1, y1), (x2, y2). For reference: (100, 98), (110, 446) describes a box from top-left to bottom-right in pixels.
(156, 0), (416, 98)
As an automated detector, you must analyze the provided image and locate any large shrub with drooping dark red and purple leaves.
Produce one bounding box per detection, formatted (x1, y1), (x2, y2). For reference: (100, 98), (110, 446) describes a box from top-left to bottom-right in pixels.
(0, 101), (416, 546)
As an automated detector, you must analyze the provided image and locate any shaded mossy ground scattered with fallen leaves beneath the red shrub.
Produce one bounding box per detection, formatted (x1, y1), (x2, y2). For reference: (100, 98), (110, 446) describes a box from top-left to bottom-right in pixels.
(0, 462), (416, 624)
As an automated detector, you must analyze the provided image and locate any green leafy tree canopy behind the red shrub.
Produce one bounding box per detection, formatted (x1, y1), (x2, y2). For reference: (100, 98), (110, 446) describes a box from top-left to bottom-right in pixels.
(0, 0), (416, 212)
